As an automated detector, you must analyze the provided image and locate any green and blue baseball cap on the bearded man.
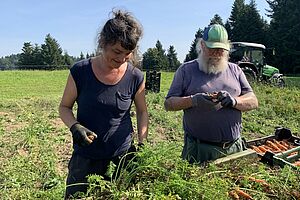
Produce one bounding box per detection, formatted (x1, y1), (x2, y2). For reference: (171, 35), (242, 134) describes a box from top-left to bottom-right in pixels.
(202, 24), (230, 51)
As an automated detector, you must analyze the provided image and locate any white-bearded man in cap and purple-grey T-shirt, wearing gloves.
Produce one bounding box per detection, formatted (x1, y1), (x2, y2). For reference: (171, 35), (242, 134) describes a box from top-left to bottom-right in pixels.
(165, 24), (258, 163)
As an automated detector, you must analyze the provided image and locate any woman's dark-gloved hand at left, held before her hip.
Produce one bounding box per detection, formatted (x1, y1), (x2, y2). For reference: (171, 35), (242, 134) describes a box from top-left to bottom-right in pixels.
(70, 123), (97, 146)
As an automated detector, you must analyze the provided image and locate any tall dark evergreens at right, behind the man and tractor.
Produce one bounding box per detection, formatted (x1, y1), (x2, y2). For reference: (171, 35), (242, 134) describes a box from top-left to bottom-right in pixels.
(185, 0), (300, 74)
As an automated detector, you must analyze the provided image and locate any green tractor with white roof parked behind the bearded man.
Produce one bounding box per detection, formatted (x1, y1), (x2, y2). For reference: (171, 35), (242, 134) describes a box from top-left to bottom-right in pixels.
(229, 42), (285, 87)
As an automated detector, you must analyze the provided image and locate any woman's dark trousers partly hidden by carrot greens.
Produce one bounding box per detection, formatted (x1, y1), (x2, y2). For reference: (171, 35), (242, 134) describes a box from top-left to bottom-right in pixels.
(65, 146), (136, 199)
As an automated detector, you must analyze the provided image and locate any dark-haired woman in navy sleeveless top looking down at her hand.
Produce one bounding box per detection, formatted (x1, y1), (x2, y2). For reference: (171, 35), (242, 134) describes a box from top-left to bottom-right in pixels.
(59, 10), (148, 198)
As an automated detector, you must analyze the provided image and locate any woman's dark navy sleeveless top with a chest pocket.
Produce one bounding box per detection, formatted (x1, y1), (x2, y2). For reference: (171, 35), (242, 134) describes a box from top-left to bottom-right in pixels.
(70, 59), (144, 159)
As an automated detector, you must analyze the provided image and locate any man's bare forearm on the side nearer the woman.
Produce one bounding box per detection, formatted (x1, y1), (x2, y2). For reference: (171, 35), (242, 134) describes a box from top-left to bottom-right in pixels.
(165, 96), (192, 111)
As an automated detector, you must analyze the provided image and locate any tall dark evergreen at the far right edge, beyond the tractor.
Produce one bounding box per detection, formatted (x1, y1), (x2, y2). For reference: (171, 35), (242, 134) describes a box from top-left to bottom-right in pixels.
(267, 0), (300, 73)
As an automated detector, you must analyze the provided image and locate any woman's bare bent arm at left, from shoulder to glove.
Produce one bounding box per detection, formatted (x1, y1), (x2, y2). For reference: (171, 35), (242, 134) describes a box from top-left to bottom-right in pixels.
(59, 74), (77, 128)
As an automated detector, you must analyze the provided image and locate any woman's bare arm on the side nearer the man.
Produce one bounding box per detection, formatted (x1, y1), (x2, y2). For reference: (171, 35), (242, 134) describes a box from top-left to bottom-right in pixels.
(134, 81), (149, 143)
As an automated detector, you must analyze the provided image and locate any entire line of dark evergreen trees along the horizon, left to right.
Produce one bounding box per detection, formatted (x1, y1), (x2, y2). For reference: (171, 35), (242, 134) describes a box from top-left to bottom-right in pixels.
(0, 0), (300, 73)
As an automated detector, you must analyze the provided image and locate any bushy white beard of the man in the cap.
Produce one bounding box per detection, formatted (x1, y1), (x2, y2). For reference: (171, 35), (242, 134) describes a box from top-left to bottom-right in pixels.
(197, 52), (228, 74)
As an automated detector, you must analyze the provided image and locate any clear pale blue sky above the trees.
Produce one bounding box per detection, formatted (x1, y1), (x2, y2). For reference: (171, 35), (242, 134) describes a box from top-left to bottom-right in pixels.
(0, 0), (269, 62)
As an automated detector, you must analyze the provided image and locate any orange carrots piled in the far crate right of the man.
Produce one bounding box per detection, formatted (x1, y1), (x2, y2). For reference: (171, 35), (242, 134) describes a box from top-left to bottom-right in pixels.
(250, 139), (294, 154)
